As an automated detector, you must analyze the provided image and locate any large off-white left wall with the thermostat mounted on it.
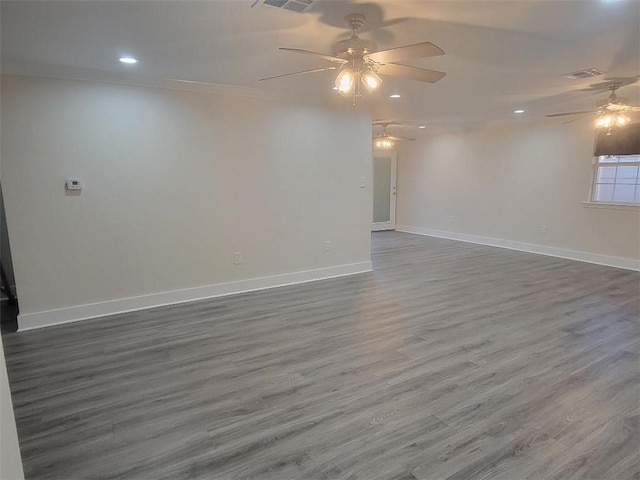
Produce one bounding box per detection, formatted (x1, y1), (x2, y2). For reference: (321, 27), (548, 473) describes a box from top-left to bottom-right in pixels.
(1, 76), (371, 328)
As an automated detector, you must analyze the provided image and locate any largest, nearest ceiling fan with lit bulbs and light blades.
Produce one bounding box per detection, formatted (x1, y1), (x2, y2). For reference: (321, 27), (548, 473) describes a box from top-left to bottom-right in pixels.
(260, 13), (446, 106)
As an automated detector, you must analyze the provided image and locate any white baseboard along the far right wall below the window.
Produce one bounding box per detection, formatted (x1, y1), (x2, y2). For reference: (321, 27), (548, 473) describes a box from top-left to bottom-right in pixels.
(396, 225), (640, 271)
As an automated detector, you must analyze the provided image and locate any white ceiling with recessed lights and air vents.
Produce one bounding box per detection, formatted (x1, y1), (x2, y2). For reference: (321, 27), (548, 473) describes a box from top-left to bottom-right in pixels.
(1, 0), (640, 132)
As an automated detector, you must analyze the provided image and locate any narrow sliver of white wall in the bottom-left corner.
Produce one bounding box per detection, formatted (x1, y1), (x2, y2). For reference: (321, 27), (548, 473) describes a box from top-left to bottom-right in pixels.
(0, 337), (24, 480)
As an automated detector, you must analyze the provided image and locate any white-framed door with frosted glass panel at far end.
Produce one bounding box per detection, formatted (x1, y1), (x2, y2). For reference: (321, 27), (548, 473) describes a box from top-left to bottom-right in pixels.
(371, 152), (396, 232)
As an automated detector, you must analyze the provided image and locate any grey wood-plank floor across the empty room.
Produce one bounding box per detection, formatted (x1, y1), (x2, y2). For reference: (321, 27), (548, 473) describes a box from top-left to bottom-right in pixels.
(4, 232), (640, 480)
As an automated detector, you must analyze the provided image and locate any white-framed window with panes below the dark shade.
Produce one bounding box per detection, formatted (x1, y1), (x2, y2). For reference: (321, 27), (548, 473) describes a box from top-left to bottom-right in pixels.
(591, 155), (640, 205)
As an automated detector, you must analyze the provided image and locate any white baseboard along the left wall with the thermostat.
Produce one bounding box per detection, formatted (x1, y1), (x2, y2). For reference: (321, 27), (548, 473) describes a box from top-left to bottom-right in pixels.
(18, 261), (373, 332)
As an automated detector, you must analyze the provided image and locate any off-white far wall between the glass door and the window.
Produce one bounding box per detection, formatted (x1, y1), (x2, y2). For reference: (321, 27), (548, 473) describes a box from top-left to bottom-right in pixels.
(397, 116), (640, 268)
